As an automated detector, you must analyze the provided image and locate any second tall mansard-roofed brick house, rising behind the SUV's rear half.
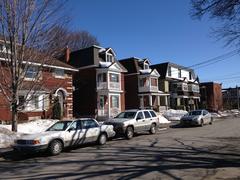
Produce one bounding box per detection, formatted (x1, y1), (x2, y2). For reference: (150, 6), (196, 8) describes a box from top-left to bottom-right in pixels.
(119, 57), (169, 112)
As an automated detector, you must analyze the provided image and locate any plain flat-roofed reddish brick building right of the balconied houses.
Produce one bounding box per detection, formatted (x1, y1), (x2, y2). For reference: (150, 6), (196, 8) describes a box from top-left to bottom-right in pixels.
(200, 82), (223, 111)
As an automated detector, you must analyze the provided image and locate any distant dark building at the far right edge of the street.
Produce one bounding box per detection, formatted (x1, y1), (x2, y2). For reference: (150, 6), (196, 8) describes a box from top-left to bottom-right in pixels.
(222, 87), (240, 109)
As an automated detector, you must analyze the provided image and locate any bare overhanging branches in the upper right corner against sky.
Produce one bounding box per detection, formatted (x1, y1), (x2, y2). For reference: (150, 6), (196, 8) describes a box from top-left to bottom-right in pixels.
(191, 0), (240, 46)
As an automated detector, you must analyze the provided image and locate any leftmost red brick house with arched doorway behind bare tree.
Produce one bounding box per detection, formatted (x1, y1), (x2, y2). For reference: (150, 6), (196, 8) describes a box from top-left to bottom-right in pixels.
(0, 44), (77, 121)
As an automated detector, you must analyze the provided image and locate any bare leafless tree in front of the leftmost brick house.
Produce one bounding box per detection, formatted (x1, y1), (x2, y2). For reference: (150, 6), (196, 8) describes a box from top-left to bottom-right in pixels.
(0, 0), (68, 131)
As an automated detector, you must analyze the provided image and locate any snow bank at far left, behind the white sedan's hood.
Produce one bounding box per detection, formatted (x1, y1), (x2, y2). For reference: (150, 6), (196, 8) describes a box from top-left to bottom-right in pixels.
(0, 119), (58, 148)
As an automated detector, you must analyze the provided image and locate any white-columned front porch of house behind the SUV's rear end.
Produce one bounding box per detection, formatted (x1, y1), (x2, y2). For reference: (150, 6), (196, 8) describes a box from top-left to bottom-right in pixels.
(138, 93), (169, 112)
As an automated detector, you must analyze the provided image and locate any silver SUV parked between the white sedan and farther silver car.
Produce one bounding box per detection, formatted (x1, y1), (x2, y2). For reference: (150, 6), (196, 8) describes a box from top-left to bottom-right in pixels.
(105, 109), (159, 139)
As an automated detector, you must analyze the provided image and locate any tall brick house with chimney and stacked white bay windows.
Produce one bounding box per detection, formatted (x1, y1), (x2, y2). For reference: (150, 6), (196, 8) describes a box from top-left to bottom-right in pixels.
(65, 45), (126, 120)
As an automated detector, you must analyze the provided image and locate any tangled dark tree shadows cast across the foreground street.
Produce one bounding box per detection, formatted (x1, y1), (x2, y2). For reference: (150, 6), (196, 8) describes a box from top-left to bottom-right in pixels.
(0, 138), (240, 180)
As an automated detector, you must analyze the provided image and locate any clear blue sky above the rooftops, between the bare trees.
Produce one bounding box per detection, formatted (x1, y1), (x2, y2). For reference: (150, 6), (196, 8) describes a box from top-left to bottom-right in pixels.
(66, 0), (240, 87)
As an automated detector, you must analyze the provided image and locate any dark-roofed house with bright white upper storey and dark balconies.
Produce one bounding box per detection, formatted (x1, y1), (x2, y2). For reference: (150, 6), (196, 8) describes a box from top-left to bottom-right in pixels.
(151, 62), (200, 111)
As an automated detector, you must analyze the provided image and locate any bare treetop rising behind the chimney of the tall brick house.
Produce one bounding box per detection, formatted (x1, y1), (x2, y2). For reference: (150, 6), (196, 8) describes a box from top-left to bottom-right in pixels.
(43, 26), (99, 57)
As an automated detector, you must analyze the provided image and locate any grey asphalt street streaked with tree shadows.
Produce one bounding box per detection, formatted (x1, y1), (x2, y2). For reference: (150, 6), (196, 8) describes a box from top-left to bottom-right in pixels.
(0, 118), (240, 179)
